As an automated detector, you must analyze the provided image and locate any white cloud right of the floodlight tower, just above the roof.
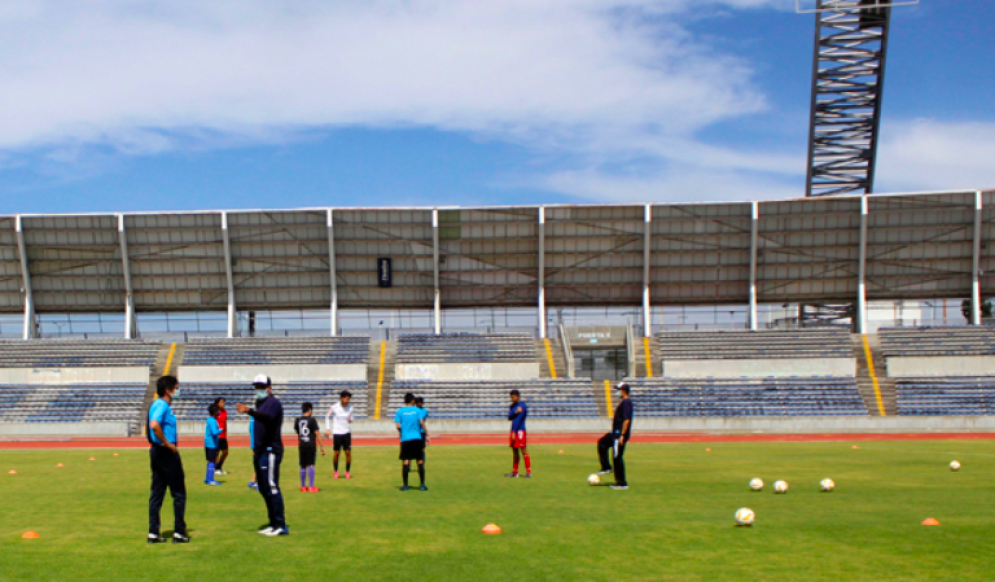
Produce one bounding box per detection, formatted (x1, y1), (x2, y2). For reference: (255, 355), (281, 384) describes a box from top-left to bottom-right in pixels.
(876, 119), (995, 192)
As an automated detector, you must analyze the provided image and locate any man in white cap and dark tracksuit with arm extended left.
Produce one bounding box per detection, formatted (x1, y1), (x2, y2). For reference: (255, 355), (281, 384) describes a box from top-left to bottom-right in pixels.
(235, 374), (290, 537)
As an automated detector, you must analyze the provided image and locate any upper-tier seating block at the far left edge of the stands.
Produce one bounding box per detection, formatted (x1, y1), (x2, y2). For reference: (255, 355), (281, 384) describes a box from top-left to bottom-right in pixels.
(0, 339), (160, 368)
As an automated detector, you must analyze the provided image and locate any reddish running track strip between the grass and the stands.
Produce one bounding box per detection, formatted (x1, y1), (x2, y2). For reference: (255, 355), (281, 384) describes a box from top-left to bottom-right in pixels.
(0, 432), (995, 450)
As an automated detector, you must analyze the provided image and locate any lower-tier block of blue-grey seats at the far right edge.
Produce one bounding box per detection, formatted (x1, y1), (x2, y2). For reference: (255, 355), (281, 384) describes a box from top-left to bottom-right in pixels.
(897, 377), (995, 416)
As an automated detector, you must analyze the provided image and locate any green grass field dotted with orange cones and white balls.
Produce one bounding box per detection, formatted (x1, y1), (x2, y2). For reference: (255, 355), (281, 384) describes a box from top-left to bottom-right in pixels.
(0, 441), (995, 582)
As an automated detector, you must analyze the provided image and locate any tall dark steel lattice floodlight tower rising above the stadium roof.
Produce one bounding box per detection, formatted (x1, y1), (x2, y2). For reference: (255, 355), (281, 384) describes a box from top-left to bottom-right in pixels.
(795, 0), (919, 196)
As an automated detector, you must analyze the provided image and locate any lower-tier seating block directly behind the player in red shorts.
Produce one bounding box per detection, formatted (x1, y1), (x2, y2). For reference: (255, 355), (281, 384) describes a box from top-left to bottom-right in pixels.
(385, 378), (598, 420)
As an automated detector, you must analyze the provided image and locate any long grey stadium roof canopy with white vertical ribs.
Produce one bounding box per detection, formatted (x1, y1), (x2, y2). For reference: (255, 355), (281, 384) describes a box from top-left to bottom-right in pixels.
(0, 191), (995, 335)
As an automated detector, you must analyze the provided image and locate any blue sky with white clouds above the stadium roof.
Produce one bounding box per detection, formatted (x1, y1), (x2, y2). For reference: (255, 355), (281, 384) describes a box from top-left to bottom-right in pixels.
(0, 0), (995, 214)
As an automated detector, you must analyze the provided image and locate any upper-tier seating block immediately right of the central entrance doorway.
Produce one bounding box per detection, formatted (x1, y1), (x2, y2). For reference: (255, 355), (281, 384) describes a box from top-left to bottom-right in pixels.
(657, 328), (853, 360)
